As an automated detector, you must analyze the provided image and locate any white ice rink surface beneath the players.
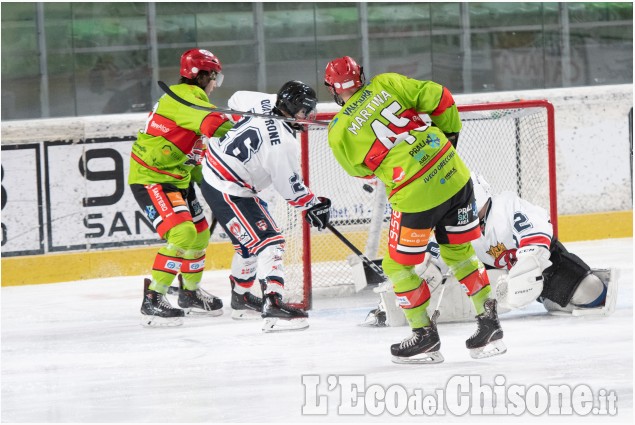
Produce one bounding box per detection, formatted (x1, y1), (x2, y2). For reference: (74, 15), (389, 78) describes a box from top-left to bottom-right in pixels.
(1, 238), (633, 424)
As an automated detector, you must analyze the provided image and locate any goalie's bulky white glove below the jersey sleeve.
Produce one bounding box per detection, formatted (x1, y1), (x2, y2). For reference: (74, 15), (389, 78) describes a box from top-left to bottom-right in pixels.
(507, 245), (551, 308)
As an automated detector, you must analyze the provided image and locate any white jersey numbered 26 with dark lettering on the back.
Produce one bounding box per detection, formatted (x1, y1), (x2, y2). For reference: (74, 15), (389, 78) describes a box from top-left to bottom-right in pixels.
(203, 91), (318, 209)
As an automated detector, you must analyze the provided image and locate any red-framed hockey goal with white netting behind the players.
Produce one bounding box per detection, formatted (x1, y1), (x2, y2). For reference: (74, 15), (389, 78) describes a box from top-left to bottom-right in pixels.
(273, 100), (558, 309)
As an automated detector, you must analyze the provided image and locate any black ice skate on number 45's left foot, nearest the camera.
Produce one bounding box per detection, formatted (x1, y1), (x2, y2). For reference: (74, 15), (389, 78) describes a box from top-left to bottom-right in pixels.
(390, 317), (445, 364)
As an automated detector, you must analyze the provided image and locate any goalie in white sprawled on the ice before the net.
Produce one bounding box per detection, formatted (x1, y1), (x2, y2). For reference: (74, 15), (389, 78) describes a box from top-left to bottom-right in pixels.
(364, 173), (617, 326)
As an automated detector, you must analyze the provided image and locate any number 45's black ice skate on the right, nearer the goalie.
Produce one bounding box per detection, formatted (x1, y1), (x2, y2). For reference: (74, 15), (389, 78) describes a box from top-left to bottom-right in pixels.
(465, 298), (507, 359)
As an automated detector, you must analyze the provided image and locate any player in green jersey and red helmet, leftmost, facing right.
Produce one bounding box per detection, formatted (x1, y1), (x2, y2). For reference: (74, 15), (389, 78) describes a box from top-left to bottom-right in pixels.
(128, 49), (232, 326)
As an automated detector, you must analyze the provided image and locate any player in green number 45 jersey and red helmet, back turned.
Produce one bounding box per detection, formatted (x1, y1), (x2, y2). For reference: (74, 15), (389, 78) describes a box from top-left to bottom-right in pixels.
(324, 56), (506, 363)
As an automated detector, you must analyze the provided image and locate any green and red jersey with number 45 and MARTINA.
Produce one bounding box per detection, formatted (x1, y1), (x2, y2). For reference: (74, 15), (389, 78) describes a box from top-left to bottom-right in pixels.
(328, 73), (470, 212)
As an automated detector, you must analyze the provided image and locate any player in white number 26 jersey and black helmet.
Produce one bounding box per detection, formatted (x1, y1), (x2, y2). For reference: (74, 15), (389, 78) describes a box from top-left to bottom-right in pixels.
(201, 81), (331, 332)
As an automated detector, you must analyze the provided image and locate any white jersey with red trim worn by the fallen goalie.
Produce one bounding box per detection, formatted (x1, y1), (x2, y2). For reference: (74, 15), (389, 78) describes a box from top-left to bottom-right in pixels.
(472, 192), (553, 270)
